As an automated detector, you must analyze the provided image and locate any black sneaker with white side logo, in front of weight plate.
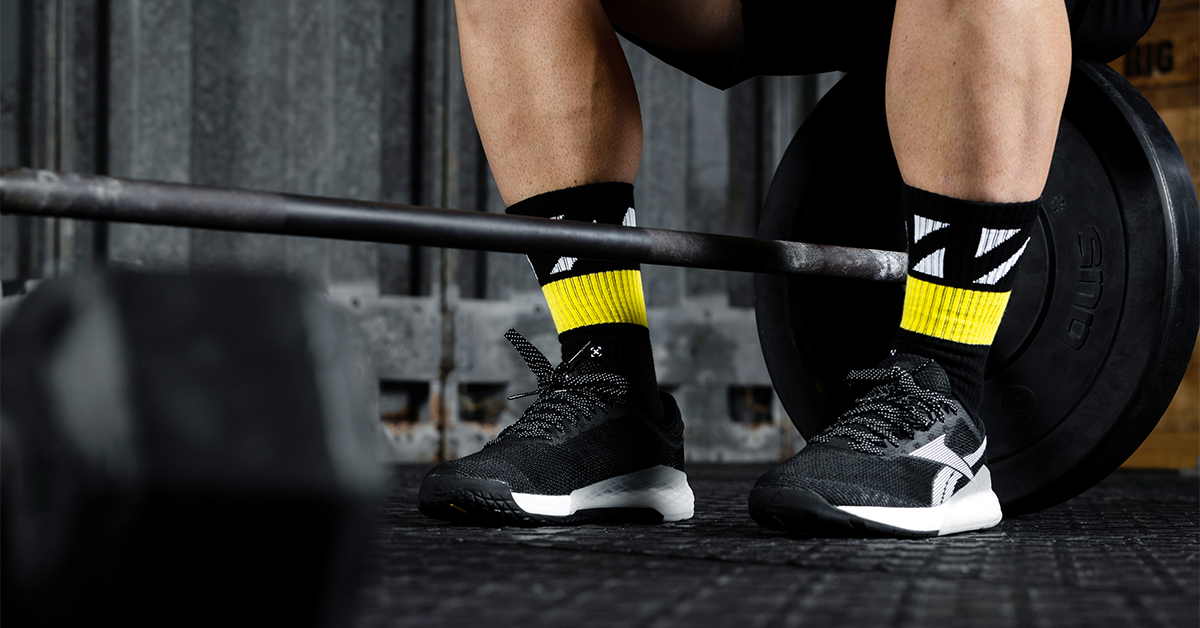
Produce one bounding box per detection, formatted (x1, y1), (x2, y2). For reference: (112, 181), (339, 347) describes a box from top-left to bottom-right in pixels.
(750, 353), (1001, 538)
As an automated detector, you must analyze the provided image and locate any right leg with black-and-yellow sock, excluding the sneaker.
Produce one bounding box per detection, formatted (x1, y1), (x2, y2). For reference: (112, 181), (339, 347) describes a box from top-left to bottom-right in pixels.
(887, 0), (1070, 407)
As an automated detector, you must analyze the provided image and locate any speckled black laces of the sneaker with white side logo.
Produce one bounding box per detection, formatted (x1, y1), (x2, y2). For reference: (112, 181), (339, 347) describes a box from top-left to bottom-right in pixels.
(812, 366), (958, 454)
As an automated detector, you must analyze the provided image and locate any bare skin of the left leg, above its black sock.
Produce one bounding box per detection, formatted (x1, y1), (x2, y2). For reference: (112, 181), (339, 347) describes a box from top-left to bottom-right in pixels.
(455, 0), (742, 205)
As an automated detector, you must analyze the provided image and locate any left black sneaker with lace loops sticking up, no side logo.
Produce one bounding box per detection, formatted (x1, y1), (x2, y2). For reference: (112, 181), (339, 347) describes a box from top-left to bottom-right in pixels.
(419, 329), (694, 525)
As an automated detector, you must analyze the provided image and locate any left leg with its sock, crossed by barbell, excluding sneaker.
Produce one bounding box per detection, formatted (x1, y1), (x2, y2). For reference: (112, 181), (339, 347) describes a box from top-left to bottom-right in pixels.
(456, 0), (742, 414)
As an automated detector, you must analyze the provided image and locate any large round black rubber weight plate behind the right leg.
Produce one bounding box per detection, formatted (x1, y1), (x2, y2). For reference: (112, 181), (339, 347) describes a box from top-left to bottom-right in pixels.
(755, 61), (1200, 515)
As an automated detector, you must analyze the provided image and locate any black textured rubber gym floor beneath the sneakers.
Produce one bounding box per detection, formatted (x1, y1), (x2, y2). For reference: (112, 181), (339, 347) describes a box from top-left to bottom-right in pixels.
(358, 465), (1200, 628)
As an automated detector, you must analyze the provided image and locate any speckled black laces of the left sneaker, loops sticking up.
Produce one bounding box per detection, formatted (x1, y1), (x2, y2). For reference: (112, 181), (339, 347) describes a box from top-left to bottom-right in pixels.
(487, 329), (629, 444)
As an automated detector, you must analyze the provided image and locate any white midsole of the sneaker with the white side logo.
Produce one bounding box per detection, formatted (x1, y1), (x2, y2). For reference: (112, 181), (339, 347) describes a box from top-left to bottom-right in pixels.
(838, 467), (1003, 536)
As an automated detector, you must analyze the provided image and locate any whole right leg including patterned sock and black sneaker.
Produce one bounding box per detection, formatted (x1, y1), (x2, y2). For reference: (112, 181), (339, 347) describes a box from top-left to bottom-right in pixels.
(750, 0), (1070, 536)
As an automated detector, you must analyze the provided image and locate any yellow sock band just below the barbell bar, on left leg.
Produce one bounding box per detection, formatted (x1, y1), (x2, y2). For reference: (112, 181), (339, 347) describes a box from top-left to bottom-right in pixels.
(541, 270), (646, 334)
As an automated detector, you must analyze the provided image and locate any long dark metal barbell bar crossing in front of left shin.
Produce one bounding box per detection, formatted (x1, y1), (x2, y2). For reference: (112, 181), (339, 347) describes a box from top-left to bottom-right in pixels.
(0, 168), (907, 281)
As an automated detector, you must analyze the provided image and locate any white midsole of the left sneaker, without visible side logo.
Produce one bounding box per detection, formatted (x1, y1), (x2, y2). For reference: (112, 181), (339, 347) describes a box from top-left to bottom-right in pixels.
(512, 465), (696, 521)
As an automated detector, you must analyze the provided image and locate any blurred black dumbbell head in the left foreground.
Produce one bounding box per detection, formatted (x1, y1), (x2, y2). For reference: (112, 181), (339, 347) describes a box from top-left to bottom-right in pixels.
(0, 271), (385, 626)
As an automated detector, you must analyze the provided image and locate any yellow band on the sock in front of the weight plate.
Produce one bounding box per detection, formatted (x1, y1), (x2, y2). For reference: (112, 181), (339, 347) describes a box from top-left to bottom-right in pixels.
(900, 275), (1012, 345)
